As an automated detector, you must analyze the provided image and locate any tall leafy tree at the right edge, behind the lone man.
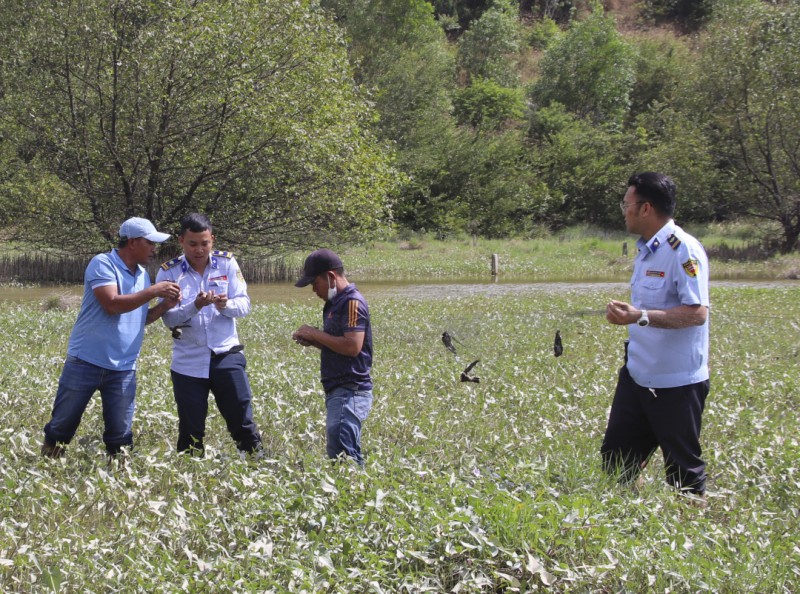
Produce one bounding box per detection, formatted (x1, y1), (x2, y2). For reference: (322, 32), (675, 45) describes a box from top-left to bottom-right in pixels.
(689, 0), (800, 252)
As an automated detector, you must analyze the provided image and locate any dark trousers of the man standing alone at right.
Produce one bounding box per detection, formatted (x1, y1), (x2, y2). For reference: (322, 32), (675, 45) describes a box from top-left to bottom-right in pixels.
(600, 366), (709, 494)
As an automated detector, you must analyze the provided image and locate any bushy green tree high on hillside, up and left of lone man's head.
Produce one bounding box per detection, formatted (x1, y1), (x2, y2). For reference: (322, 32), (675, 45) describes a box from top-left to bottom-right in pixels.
(531, 4), (634, 123)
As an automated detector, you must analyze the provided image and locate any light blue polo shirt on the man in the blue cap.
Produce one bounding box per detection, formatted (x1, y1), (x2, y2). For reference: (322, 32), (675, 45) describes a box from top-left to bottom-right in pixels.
(67, 249), (150, 371)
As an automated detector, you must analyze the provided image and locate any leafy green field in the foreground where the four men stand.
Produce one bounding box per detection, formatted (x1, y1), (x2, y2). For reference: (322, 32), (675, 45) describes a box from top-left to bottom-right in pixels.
(0, 272), (800, 594)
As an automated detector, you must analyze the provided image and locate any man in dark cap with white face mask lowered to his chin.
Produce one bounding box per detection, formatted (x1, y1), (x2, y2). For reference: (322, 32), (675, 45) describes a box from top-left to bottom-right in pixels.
(292, 249), (372, 466)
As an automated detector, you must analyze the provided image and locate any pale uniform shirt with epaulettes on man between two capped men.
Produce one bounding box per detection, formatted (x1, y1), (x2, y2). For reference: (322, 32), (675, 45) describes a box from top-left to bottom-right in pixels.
(156, 250), (250, 378)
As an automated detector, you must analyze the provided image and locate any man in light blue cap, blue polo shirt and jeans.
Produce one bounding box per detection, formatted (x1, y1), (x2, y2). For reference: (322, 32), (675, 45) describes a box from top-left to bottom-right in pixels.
(42, 217), (180, 458)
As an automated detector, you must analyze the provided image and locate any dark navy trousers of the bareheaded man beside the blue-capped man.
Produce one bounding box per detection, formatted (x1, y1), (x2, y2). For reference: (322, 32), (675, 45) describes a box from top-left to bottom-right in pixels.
(172, 353), (261, 453)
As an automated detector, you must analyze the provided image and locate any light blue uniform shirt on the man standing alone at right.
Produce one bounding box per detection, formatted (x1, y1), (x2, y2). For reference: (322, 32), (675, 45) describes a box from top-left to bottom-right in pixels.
(628, 220), (710, 388)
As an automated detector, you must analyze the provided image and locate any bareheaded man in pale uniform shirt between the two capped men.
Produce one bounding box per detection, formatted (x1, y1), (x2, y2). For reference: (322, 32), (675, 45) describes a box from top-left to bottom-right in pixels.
(156, 213), (262, 456)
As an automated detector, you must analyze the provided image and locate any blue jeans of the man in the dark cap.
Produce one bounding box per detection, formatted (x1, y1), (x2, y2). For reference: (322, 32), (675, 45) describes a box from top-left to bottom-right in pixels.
(325, 388), (372, 466)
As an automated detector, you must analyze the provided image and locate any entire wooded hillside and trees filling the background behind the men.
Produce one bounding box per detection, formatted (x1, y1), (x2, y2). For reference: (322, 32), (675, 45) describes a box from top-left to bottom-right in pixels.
(0, 0), (800, 253)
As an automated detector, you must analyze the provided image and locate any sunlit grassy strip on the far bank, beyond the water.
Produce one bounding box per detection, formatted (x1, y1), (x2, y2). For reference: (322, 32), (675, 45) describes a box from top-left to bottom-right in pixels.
(330, 223), (800, 282)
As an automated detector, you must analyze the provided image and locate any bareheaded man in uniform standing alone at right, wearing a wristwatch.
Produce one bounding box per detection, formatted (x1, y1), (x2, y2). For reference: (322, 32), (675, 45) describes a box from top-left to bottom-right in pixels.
(601, 172), (710, 497)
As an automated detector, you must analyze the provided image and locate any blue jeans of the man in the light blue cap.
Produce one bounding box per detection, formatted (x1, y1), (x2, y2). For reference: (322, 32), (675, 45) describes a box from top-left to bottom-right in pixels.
(44, 355), (136, 454)
